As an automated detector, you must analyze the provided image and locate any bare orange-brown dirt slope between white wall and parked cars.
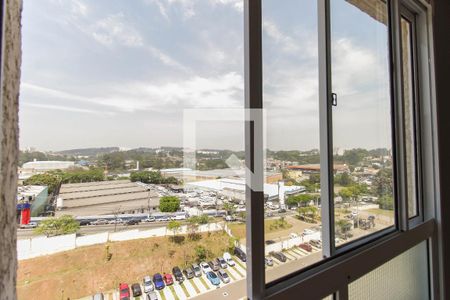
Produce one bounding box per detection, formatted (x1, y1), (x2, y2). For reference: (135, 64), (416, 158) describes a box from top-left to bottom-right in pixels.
(17, 232), (229, 300)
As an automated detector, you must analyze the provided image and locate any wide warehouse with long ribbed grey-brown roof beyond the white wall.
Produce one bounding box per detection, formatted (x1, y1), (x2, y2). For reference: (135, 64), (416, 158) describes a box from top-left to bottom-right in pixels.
(56, 180), (159, 216)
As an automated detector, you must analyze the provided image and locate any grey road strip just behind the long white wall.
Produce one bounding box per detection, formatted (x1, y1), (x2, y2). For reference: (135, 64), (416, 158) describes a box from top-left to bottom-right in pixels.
(17, 222), (177, 239)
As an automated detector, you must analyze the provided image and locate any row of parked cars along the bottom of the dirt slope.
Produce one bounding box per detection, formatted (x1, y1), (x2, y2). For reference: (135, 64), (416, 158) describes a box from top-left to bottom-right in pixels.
(119, 250), (239, 300)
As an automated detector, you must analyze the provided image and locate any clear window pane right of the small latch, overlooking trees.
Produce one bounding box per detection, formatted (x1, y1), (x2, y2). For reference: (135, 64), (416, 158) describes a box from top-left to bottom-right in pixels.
(331, 0), (395, 246)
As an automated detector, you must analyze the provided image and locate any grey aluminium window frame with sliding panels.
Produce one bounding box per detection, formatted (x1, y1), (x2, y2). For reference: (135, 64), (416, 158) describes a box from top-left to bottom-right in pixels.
(244, 0), (442, 299)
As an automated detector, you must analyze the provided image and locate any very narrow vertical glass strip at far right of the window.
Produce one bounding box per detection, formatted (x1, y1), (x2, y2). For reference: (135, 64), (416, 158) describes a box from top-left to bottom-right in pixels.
(400, 17), (418, 217)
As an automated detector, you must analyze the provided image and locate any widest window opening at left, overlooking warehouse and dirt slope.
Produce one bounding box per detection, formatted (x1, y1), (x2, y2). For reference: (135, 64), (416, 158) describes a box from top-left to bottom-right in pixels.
(17, 0), (246, 299)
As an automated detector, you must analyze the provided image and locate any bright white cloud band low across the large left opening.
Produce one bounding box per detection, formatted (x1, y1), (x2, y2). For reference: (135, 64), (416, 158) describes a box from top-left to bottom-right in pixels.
(21, 73), (244, 113)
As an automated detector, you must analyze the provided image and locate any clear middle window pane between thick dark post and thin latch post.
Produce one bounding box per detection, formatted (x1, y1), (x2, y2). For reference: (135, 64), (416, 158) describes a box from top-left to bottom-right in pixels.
(262, 0), (322, 282)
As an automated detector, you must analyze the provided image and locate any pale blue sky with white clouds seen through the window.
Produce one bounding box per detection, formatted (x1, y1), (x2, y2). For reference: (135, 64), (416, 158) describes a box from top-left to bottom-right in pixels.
(19, 0), (390, 150)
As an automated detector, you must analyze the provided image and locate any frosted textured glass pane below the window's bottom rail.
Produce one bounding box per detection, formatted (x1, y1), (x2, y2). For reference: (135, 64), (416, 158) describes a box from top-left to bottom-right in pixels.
(348, 241), (429, 300)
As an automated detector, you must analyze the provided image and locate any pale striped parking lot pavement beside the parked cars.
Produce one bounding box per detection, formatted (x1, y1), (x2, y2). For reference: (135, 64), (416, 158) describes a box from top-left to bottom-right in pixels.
(83, 246), (320, 300)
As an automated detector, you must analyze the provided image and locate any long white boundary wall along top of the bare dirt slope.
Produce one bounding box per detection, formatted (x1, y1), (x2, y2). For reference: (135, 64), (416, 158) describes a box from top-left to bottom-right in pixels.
(17, 223), (223, 260)
